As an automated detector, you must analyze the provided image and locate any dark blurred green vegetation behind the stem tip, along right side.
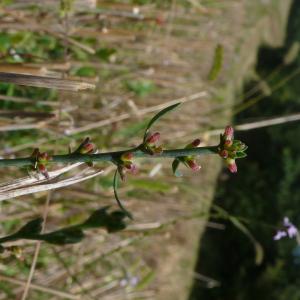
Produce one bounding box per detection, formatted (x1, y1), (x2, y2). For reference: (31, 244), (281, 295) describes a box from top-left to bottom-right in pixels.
(190, 1), (300, 300)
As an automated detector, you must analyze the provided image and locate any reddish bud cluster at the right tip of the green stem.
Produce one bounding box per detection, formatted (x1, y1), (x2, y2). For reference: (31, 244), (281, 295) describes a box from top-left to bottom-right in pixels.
(219, 126), (248, 173)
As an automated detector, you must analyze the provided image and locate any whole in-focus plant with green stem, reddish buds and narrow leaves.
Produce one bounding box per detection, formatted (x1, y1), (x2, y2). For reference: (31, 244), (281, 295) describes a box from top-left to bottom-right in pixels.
(0, 103), (247, 217)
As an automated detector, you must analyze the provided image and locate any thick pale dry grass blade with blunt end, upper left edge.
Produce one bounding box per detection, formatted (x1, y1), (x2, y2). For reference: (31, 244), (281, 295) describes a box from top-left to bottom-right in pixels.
(0, 72), (95, 91)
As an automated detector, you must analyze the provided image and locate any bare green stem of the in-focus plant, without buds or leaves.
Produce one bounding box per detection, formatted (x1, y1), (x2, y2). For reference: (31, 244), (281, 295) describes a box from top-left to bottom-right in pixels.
(0, 146), (218, 168)
